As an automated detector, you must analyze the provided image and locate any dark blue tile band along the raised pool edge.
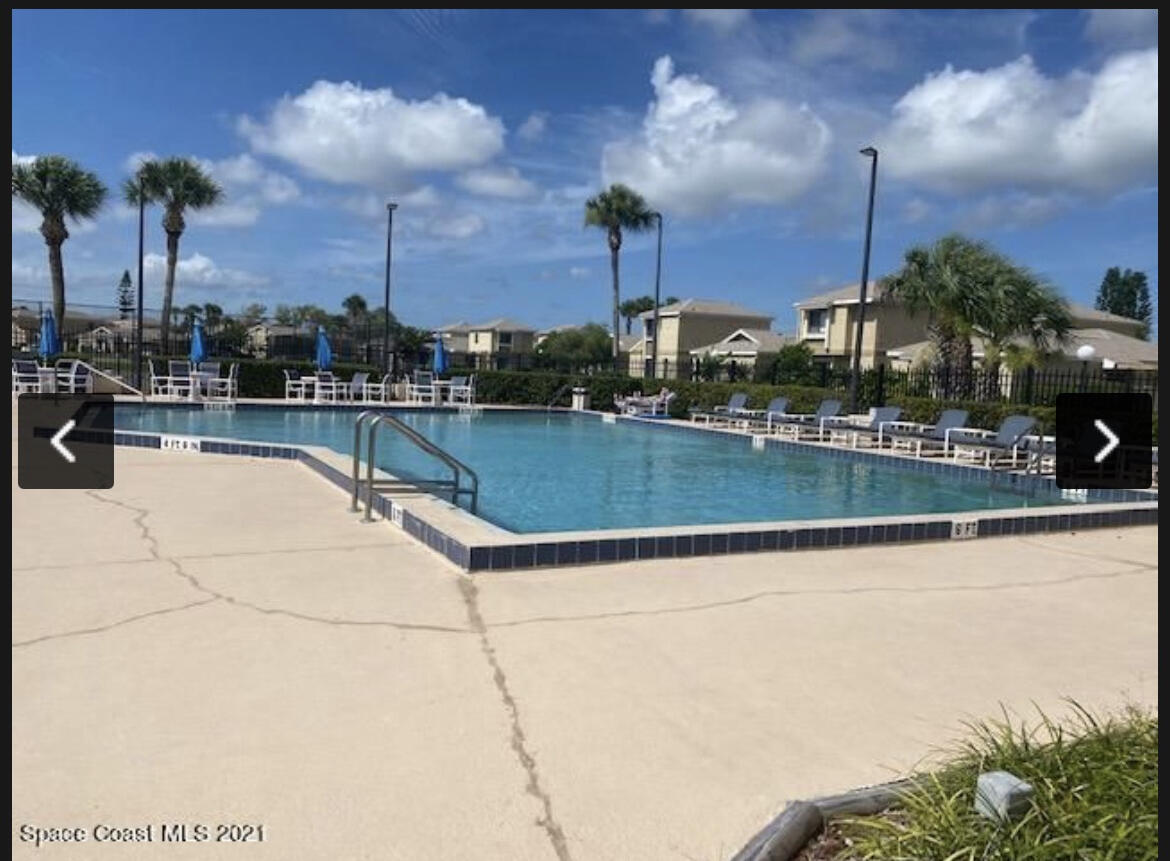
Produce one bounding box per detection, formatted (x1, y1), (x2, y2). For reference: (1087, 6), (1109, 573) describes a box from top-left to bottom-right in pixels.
(105, 402), (1158, 572)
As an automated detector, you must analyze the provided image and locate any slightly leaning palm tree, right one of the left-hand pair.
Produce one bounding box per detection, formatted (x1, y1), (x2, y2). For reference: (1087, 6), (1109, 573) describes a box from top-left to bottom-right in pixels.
(122, 158), (223, 351)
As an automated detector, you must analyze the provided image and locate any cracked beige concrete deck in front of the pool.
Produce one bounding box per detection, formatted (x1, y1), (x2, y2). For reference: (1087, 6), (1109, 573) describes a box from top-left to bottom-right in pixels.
(12, 439), (1157, 861)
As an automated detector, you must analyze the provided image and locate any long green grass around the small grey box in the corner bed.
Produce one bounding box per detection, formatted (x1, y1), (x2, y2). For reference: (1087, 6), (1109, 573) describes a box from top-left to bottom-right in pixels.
(820, 703), (1158, 861)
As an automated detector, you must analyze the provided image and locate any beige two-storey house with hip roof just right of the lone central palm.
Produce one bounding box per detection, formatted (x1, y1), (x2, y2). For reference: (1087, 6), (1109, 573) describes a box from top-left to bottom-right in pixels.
(628, 298), (772, 377)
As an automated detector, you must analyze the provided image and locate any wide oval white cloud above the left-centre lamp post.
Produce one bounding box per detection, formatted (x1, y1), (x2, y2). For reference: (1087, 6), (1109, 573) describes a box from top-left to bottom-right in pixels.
(239, 81), (504, 188)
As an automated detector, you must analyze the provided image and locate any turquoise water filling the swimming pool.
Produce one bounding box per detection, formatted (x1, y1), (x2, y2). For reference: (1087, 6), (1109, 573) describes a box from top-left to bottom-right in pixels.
(117, 405), (1067, 532)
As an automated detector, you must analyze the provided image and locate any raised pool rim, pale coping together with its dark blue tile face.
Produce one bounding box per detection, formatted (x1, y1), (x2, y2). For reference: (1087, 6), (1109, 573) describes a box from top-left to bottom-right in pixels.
(113, 401), (1158, 572)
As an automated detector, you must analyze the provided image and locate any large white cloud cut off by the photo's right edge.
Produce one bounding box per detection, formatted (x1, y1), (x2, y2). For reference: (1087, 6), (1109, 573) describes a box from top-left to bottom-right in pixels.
(878, 48), (1158, 193)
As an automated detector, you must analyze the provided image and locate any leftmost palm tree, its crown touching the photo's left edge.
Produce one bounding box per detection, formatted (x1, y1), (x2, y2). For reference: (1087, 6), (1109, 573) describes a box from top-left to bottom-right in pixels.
(12, 156), (106, 326)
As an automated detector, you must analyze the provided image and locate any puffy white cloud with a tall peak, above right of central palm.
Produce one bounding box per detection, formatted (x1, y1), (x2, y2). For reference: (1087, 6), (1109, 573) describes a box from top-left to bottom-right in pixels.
(601, 56), (831, 214)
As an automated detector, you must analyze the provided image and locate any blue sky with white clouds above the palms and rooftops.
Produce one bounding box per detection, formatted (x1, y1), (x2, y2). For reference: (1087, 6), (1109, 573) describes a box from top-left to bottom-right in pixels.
(12, 9), (1157, 331)
